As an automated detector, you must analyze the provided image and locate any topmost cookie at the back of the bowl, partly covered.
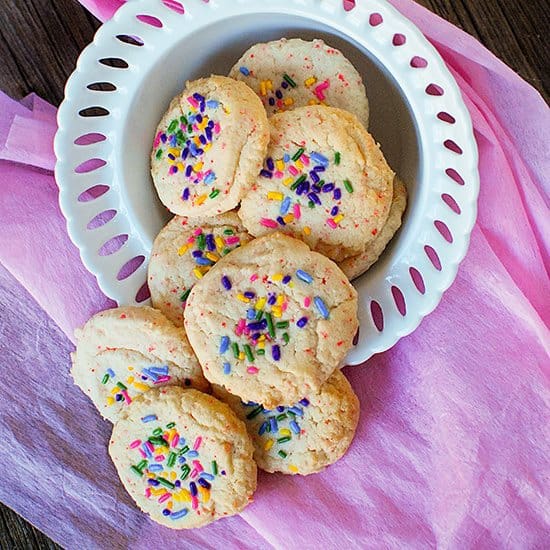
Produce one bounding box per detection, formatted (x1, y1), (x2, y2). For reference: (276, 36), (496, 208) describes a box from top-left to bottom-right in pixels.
(229, 38), (369, 128)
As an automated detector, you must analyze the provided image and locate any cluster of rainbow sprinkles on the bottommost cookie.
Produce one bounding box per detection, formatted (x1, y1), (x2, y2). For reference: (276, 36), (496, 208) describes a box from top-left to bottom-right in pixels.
(128, 422), (226, 521)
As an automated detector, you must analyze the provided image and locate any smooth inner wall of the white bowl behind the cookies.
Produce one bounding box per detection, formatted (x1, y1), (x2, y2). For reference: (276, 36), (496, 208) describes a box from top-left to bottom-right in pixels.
(121, 14), (421, 274)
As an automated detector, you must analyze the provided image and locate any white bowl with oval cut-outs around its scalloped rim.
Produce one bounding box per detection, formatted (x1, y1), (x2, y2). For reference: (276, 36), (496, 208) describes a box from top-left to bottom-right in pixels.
(55, 0), (479, 364)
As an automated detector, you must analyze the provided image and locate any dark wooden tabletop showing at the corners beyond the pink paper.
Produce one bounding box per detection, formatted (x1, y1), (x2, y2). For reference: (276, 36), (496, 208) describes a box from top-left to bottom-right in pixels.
(0, 0), (550, 549)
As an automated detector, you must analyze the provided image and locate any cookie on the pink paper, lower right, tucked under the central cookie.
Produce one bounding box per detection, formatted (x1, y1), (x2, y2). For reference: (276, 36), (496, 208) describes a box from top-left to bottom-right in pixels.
(214, 371), (359, 475)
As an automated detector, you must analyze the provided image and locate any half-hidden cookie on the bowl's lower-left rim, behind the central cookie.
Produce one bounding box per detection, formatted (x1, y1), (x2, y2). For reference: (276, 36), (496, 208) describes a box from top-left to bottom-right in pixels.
(147, 211), (251, 327)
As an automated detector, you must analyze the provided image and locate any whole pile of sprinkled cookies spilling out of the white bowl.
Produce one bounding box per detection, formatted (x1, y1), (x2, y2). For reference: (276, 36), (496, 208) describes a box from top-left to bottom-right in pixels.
(72, 39), (406, 529)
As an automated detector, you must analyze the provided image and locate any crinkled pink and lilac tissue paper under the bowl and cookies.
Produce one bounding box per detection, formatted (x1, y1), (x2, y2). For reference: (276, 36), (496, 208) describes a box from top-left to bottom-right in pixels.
(0, 0), (550, 548)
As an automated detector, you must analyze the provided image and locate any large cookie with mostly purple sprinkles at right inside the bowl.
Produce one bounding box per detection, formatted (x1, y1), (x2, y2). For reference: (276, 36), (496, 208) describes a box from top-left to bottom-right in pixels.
(239, 106), (394, 261)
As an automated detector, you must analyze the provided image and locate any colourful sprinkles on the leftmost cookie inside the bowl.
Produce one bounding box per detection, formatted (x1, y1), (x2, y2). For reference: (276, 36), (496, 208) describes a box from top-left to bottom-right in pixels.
(153, 93), (227, 205)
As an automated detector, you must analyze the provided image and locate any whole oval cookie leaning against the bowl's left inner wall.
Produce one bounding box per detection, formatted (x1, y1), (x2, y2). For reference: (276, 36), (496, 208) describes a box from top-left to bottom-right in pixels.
(151, 76), (269, 217)
